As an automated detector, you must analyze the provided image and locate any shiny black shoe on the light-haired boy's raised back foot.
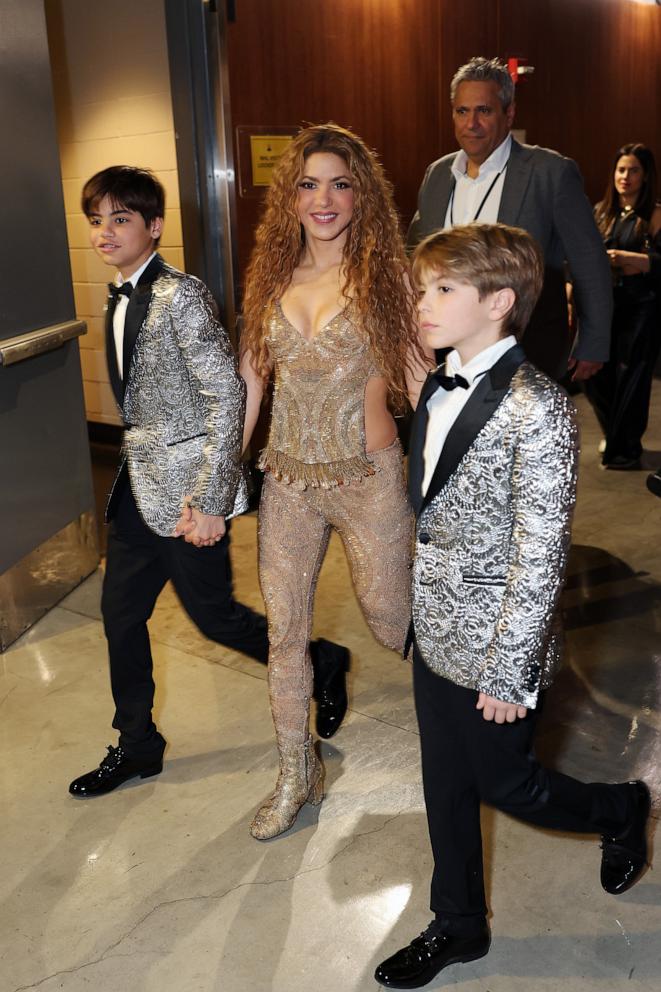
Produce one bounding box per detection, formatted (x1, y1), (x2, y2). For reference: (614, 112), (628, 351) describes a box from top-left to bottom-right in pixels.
(601, 782), (652, 896)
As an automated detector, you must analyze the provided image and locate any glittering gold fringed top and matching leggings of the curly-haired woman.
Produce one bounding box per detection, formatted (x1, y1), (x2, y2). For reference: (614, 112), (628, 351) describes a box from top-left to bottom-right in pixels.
(259, 304), (412, 744)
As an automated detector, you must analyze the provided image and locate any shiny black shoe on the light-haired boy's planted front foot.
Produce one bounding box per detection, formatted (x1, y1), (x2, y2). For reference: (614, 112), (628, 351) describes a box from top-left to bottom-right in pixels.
(374, 923), (491, 989)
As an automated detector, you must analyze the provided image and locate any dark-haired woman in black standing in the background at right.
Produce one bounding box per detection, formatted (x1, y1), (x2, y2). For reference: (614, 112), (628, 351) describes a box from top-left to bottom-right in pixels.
(585, 142), (661, 470)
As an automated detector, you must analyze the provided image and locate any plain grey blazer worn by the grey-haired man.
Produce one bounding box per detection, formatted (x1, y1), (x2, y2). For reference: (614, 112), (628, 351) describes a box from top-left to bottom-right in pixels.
(407, 139), (613, 377)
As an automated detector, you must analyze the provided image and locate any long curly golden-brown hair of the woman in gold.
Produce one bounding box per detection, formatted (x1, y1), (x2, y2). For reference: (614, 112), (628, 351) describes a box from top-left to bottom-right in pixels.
(241, 123), (422, 409)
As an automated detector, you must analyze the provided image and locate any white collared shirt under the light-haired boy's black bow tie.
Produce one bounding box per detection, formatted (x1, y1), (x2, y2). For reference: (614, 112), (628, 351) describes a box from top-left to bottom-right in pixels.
(422, 334), (516, 496)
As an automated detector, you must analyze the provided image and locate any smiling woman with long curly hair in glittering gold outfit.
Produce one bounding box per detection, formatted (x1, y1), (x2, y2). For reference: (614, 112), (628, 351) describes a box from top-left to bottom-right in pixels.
(241, 124), (432, 840)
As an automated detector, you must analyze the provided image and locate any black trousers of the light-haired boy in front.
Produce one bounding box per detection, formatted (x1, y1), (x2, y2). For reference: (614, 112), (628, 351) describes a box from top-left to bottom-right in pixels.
(413, 648), (631, 936)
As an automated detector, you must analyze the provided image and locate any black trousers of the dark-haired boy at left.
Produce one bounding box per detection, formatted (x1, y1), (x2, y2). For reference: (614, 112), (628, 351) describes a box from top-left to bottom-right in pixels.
(101, 480), (268, 756)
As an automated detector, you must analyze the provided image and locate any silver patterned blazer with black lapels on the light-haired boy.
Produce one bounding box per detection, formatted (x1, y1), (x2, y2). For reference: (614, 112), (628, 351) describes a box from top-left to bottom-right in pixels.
(409, 345), (578, 708)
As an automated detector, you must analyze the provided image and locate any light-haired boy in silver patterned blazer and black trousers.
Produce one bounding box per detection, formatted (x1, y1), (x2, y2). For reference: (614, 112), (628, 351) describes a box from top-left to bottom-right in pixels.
(375, 224), (650, 989)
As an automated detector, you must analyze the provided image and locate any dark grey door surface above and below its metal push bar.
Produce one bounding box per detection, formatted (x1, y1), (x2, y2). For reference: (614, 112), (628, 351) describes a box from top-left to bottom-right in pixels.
(0, 0), (94, 608)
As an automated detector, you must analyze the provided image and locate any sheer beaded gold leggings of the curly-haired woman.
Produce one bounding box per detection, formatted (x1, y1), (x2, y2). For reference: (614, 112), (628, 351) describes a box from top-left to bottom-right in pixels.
(259, 441), (413, 744)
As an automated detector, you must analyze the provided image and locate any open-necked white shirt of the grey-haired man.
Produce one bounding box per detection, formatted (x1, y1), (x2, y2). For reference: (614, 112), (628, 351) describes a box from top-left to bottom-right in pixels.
(445, 134), (512, 227)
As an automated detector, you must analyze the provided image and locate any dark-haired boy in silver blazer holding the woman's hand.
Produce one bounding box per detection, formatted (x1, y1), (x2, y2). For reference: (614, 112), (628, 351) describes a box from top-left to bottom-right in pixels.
(69, 166), (347, 798)
